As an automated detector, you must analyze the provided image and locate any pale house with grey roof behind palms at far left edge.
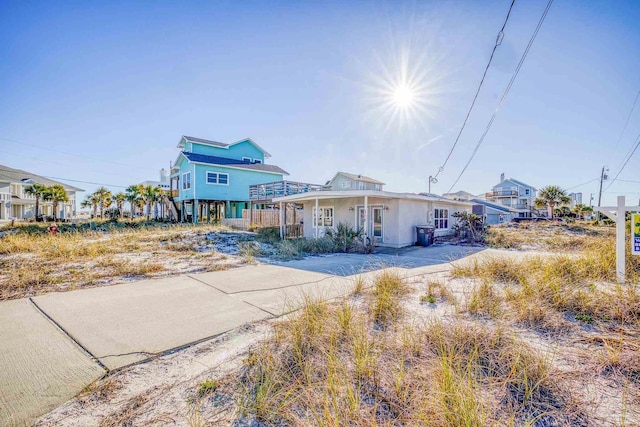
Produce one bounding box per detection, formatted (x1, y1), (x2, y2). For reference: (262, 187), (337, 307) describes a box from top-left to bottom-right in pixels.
(0, 165), (84, 220)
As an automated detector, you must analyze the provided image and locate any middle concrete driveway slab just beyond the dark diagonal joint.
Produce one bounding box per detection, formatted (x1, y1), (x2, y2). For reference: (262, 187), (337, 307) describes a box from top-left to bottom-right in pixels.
(34, 276), (269, 369)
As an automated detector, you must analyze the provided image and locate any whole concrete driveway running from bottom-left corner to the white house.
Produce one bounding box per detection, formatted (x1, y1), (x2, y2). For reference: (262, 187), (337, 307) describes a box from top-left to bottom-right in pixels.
(0, 245), (488, 425)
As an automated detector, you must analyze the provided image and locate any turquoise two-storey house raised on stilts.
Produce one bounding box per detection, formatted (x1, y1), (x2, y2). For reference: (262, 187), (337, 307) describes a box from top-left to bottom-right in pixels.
(169, 136), (289, 223)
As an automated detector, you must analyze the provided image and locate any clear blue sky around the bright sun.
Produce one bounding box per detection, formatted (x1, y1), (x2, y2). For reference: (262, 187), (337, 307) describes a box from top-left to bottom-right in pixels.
(0, 0), (640, 204)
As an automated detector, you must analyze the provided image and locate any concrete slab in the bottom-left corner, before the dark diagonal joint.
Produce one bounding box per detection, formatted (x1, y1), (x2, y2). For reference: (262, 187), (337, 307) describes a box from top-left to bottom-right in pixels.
(0, 299), (105, 425)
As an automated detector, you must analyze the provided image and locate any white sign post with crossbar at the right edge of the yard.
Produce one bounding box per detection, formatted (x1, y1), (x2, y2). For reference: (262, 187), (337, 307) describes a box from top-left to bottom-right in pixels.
(594, 196), (640, 283)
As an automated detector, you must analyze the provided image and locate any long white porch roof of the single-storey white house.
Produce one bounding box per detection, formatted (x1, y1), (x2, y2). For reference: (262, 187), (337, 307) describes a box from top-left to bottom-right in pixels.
(273, 190), (473, 207)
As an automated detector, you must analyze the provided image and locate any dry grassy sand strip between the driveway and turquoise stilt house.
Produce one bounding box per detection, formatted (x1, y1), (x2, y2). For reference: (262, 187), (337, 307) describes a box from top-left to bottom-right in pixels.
(0, 225), (253, 300)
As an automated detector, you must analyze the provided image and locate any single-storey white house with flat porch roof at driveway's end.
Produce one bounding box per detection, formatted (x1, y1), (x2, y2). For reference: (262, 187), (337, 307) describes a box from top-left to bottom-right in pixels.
(273, 190), (471, 248)
